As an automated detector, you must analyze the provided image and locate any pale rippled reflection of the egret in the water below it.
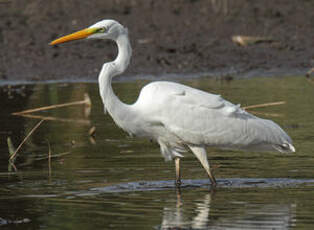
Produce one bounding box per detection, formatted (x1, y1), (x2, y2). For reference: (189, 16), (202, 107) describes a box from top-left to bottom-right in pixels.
(157, 190), (296, 230)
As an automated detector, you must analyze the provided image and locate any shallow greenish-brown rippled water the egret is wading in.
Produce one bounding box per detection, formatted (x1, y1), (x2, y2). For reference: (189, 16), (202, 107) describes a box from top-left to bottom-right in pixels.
(0, 76), (314, 229)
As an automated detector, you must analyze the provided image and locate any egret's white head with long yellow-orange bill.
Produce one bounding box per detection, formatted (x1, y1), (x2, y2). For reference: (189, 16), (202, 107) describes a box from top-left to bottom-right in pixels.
(50, 19), (127, 45)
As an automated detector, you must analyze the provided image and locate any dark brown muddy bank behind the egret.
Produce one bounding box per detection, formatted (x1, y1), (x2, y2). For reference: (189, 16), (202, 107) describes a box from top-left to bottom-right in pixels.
(0, 0), (314, 80)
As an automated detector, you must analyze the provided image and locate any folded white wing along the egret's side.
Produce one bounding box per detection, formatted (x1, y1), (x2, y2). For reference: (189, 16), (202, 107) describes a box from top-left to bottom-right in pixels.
(134, 82), (289, 148)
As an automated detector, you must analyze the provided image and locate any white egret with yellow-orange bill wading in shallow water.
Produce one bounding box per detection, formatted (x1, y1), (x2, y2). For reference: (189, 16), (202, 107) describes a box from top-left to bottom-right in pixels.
(50, 20), (295, 186)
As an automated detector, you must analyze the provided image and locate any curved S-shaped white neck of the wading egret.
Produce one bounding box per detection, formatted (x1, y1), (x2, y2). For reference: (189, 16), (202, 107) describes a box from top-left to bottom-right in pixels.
(98, 32), (132, 128)
